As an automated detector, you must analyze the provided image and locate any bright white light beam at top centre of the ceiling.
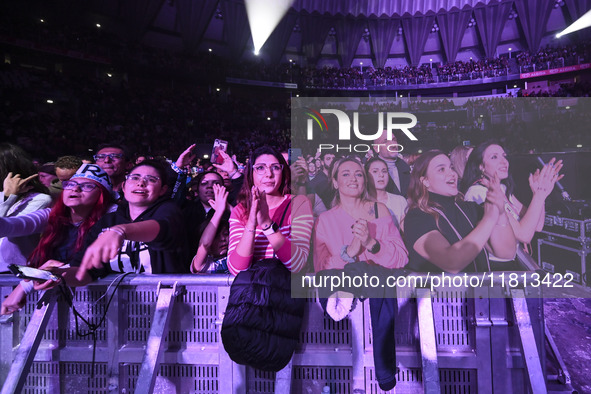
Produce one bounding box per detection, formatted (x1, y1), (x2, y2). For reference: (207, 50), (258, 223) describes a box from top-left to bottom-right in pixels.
(244, 0), (295, 55)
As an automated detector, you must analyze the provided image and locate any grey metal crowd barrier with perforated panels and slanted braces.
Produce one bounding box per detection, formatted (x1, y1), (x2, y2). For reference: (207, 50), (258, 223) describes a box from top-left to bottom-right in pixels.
(0, 275), (572, 394)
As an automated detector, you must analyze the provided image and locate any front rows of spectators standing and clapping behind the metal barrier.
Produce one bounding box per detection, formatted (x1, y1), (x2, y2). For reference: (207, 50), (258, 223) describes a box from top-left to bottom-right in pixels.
(0, 133), (563, 314)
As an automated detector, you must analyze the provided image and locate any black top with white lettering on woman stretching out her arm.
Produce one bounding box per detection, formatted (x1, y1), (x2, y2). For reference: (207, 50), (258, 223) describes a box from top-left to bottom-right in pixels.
(73, 198), (189, 277)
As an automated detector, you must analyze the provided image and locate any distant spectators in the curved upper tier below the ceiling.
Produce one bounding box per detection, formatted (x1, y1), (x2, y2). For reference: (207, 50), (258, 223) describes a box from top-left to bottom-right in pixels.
(0, 9), (591, 89)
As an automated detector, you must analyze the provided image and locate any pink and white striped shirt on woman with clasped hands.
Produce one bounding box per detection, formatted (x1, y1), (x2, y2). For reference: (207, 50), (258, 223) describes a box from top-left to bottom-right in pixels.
(228, 196), (314, 275)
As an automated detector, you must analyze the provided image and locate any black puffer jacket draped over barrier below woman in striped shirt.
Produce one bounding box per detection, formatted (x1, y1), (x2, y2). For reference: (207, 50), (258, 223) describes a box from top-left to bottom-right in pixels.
(222, 259), (306, 372)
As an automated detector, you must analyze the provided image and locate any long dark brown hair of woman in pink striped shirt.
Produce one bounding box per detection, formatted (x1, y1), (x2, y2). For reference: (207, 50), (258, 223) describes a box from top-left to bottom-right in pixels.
(236, 145), (291, 217)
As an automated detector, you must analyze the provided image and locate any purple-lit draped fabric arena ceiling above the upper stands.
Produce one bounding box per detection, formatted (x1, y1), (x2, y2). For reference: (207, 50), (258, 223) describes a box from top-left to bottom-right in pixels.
(87, 0), (591, 67)
